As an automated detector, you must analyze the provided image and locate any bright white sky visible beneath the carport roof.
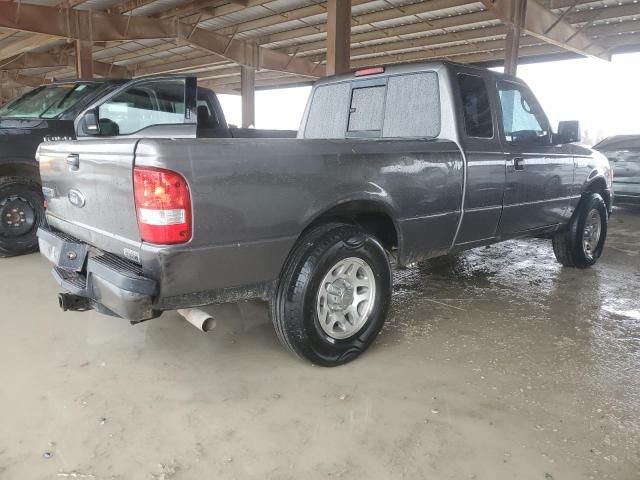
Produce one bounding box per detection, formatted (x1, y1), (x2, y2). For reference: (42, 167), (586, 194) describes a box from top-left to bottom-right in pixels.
(220, 53), (640, 145)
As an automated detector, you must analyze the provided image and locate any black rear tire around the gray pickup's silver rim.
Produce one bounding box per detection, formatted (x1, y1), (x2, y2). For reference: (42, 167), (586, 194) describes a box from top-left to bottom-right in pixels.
(271, 223), (392, 367)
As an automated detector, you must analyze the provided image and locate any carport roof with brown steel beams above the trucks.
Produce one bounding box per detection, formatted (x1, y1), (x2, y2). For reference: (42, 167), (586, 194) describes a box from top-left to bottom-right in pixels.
(0, 0), (640, 125)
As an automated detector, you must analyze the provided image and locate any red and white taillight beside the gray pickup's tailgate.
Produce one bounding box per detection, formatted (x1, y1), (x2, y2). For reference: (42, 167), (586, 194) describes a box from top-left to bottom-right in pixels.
(133, 167), (192, 245)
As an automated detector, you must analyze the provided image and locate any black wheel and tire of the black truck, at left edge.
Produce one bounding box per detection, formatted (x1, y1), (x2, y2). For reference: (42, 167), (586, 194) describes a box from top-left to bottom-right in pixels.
(0, 177), (45, 257)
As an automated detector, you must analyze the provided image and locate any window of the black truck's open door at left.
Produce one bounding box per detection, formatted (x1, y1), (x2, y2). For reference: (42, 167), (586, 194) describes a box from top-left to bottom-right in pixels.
(98, 79), (185, 136)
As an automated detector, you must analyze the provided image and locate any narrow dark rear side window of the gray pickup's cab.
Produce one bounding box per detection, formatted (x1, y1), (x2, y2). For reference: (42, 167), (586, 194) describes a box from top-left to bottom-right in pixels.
(458, 73), (493, 138)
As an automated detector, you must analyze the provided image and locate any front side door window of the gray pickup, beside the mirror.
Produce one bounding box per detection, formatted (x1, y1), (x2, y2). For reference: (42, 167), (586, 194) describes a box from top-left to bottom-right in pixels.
(498, 81), (549, 143)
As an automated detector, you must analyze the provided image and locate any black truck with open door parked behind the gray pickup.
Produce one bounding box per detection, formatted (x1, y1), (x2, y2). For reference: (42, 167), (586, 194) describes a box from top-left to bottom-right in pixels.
(0, 78), (295, 257)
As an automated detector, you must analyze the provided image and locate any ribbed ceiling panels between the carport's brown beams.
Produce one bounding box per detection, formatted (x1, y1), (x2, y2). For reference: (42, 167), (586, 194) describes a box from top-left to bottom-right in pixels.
(0, 0), (640, 98)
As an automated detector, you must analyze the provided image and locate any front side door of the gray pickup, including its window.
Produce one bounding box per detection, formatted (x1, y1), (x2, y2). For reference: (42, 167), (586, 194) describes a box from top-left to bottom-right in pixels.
(497, 80), (574, 236)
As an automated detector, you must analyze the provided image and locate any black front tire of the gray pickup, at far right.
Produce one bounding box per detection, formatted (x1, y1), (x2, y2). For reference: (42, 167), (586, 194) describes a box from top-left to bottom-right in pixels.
(552, 193), (609, 268)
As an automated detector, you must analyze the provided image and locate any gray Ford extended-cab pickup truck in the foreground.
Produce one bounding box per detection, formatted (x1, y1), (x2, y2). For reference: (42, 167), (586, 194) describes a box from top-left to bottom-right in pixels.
(37, 62), (612, 366)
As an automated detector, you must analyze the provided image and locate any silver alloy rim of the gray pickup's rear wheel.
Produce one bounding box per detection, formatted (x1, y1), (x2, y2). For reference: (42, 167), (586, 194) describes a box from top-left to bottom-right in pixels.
(316, 257), (376, 340)
